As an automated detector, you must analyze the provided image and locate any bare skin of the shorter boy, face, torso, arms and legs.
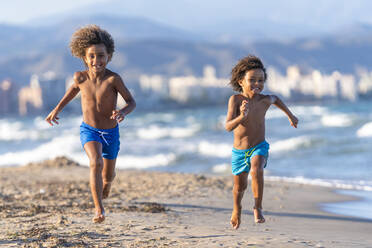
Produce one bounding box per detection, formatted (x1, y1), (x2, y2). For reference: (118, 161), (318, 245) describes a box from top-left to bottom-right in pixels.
(225, 69), (298, 229)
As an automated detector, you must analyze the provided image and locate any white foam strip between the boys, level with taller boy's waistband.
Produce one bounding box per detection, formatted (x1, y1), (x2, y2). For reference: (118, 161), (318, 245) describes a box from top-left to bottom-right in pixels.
(137, 124), (200, 139)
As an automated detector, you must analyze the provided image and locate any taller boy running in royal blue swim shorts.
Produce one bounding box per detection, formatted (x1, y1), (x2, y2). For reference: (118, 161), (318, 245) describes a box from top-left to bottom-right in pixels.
(45, 25), (136, 223)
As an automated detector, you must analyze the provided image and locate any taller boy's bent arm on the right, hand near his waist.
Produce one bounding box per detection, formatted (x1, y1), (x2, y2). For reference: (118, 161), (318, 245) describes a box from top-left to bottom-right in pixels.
(110, 76), (136, 122)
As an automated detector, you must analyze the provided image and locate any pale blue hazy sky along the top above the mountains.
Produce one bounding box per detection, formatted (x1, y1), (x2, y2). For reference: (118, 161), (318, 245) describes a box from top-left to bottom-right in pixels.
(0, 0), (372, 35)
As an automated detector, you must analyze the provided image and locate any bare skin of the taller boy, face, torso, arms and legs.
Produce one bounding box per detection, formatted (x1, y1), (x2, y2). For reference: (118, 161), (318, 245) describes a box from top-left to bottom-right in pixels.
(45, 44), (136, 222)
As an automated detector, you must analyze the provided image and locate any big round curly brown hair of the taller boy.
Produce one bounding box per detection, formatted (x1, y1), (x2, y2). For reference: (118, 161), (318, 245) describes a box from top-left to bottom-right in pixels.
(70, 25), (115, 59)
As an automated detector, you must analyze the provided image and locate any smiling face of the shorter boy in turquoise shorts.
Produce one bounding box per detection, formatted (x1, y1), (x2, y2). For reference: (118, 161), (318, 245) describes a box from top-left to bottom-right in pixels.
(239, 69), (265, 95)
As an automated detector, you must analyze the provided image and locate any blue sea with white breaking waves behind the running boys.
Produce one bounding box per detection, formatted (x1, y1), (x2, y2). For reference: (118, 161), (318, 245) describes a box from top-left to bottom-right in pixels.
(0, 102), (372, 219)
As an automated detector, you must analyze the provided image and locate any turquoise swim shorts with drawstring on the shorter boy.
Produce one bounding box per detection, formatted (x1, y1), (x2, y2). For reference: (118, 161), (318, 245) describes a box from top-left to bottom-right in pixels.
(231, 141), (270, 175)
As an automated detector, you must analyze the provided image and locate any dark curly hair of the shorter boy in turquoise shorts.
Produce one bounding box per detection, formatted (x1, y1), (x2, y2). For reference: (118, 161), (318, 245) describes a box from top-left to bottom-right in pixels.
(230, 55), (267, 92)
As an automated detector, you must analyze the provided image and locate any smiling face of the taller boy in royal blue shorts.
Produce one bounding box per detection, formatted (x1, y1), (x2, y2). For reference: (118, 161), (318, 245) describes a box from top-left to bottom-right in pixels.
(84, 44), (110, 73)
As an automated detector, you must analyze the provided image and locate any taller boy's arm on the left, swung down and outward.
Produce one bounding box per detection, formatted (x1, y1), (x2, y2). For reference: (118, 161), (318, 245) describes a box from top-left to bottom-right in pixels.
(45, 73), (80, 126)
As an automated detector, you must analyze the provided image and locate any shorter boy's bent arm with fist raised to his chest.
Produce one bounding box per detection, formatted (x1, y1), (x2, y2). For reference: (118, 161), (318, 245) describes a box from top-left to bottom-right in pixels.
(225, 95), (249, 132)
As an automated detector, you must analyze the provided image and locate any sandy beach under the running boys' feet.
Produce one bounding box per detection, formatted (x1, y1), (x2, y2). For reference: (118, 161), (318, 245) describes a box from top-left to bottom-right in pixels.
(0, 158), (372, 247)
